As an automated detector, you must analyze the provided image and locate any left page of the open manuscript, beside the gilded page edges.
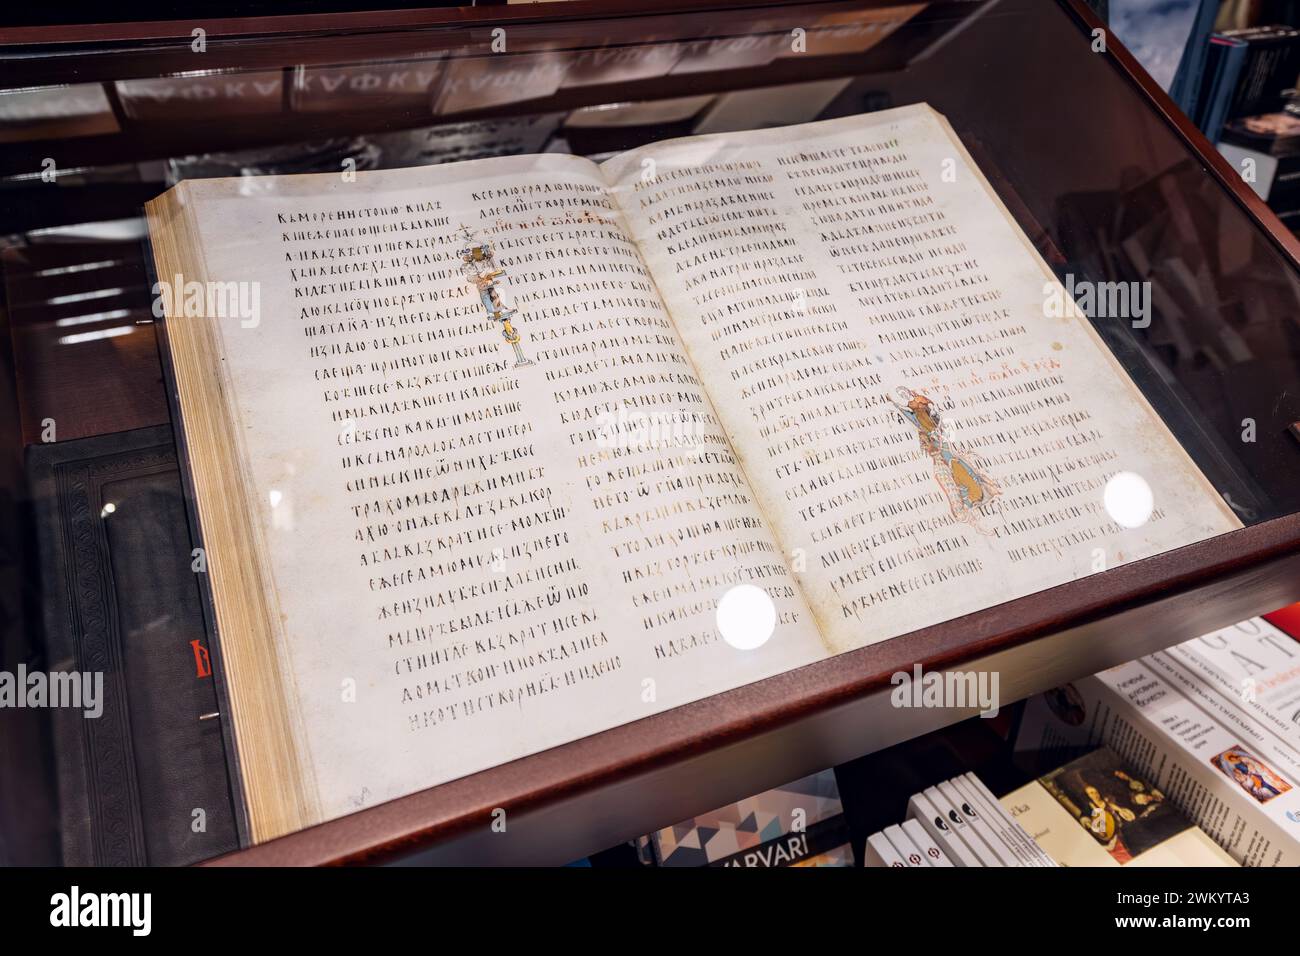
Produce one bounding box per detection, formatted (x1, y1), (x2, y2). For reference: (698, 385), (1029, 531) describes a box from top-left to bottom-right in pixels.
(175, 156), (826, 818)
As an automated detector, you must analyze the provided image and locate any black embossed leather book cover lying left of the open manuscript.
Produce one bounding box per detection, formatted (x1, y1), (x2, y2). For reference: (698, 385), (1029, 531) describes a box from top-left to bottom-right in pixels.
(27, 425), (239, 866)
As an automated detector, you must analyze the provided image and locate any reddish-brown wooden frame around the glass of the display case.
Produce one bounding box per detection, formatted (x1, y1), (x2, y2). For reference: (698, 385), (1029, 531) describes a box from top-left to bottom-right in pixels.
(0, 0), (1300, 865)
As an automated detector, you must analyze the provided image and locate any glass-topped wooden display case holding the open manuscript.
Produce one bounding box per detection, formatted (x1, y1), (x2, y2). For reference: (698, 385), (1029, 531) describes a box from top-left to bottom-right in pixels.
(0, 0), (1300, 864)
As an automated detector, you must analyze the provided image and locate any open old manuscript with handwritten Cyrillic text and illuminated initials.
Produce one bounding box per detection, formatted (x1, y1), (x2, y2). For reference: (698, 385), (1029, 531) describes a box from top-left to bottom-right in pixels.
(148, 105), (1239, 840)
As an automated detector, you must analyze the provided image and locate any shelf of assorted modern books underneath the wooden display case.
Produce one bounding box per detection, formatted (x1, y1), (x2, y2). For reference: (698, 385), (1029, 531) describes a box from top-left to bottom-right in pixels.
(618, 607), (1300, 868)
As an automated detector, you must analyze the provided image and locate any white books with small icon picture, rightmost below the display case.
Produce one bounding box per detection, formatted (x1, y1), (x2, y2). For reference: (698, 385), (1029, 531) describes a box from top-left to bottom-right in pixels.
(1013, 618), (1300, 866)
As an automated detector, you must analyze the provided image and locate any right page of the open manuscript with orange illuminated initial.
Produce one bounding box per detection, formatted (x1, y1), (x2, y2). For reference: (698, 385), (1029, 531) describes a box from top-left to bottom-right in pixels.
(602, 104), (1240, 652)
